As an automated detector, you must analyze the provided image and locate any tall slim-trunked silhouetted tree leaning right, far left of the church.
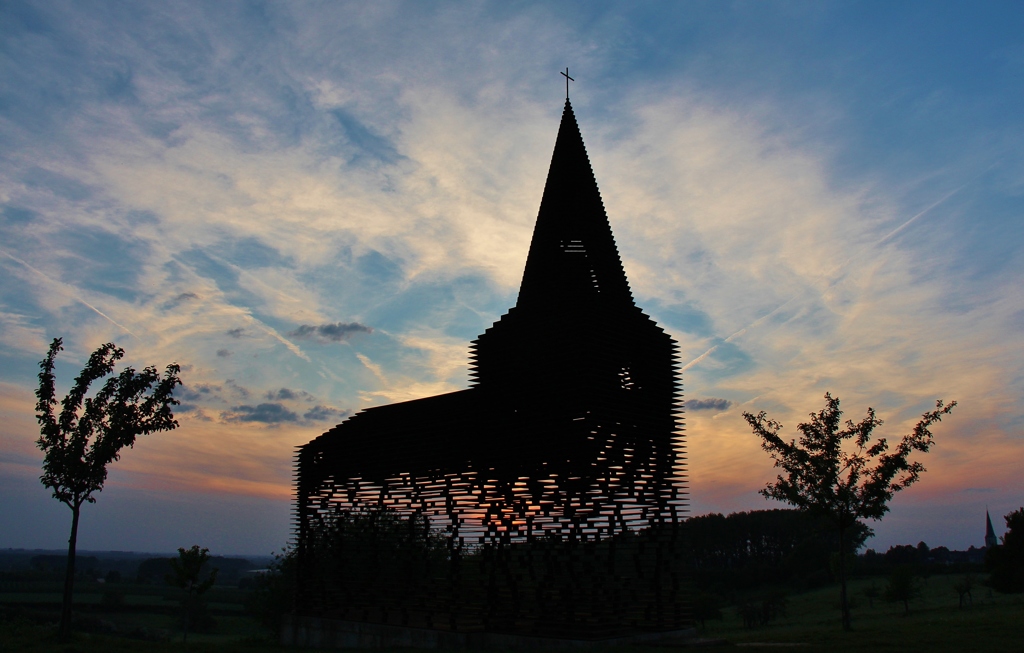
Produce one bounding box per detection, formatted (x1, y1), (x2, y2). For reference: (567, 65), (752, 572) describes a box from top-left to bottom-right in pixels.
(36, 338), (181, 640)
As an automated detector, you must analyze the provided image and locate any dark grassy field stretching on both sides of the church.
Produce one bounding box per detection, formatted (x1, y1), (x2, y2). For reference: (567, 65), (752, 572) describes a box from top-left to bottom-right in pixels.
(0, 575), (1024, 653)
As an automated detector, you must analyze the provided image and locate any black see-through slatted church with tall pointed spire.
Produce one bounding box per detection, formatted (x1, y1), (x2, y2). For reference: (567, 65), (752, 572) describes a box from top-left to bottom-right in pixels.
(296, 98), (688, 639)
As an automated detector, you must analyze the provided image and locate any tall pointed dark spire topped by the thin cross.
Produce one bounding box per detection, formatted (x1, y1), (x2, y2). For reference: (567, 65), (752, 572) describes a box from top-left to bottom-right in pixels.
(516, 98), (633, 308)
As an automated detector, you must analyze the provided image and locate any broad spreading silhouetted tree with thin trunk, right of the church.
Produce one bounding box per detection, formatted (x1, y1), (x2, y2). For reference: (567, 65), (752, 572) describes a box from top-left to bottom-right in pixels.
(743, 393), (956, 630)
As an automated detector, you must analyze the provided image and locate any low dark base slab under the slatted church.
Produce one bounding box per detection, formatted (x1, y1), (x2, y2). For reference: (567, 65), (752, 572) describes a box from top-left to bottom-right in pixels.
(281, 615), (696, 651)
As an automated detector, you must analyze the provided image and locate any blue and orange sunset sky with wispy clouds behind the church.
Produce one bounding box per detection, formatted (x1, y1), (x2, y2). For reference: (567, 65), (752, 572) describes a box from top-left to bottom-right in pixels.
(0, 2), (1024, 554)
